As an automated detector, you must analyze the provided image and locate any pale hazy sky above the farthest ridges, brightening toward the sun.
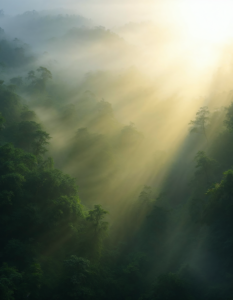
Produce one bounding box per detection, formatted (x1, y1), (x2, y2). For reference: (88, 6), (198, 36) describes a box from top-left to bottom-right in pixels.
(0, 0), (233, 41)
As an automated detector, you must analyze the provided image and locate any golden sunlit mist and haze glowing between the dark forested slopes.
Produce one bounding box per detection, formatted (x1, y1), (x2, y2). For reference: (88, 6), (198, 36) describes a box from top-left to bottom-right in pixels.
(0, 0), (233, 206)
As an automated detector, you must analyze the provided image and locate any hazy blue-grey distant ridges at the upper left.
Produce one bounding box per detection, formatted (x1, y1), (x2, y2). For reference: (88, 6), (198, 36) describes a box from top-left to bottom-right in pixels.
(0, 10), (91, 69)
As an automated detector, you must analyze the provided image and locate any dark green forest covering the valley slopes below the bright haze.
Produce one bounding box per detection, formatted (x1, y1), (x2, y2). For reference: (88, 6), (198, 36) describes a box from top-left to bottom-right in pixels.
(0, 9), (233, 300)
